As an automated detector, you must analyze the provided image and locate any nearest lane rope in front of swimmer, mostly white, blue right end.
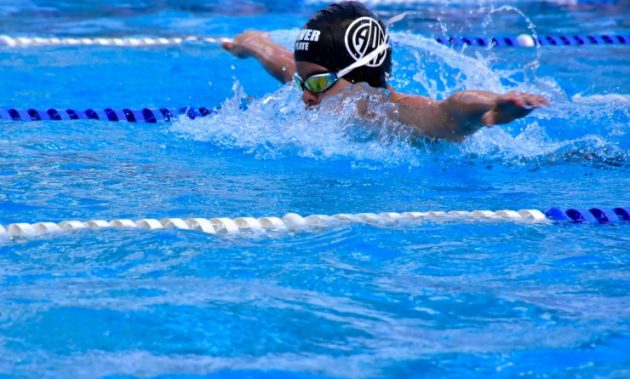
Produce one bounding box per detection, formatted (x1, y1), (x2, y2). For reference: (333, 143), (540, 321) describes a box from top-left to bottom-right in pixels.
(0, 208), (630, 242)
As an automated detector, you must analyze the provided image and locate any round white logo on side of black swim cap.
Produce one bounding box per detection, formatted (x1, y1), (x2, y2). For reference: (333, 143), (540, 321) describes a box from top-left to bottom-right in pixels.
(345, 17), (387, 67)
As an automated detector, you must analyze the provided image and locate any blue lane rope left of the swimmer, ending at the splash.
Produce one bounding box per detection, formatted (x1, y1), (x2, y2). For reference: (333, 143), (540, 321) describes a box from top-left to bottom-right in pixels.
(0, 107), (217, 124)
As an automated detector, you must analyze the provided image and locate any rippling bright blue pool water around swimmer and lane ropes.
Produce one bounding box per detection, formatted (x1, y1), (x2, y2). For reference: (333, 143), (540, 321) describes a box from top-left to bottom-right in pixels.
(0, 0), (630, 378)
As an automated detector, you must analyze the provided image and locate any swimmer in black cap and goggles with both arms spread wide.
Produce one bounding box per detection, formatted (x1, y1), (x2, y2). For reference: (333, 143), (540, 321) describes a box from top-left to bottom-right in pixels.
(222, 1), (549, 142)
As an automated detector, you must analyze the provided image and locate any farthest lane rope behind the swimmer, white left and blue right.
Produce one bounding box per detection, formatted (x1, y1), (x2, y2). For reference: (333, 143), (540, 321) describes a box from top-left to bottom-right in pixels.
(0, 34), (630, 48)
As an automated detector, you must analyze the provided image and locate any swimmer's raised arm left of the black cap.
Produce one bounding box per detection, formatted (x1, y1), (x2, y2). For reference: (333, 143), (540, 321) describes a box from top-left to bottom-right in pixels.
(221, 31), (295, 84)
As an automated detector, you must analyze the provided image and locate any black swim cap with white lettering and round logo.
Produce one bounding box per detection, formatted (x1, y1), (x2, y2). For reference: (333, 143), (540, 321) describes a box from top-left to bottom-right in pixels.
(294, 1), (392, 88)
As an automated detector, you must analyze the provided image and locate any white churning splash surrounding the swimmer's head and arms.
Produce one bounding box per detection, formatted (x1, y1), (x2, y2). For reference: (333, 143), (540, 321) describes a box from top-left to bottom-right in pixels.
(172, 30), (629, 168)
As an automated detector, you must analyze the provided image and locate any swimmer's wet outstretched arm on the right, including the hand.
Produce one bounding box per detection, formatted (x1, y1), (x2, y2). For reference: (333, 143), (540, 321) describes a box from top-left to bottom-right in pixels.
(391, 91), (549, 141)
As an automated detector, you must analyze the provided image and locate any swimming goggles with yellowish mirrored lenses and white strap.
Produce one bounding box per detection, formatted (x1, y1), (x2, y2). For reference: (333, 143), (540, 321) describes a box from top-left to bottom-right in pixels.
(293, 12), (407, 93)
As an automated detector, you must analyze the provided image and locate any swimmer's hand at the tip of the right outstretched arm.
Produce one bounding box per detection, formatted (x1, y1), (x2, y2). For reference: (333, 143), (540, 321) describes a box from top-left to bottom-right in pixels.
(481, 91), (549, 127)
